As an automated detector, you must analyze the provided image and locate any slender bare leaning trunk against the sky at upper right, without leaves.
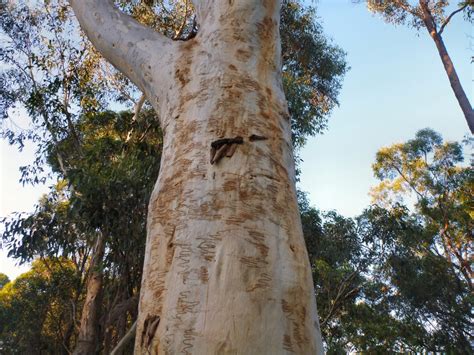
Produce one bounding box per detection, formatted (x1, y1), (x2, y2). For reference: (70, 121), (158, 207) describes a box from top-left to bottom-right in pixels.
(420, 0), (474, 134)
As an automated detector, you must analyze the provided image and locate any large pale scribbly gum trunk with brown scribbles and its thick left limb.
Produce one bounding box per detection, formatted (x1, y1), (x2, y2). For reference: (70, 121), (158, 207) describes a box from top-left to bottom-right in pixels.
(70, 0), (323, 354)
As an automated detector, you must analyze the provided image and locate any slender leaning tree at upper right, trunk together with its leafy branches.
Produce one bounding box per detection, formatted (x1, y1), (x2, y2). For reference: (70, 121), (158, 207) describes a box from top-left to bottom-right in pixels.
(357, 0), (474, 133)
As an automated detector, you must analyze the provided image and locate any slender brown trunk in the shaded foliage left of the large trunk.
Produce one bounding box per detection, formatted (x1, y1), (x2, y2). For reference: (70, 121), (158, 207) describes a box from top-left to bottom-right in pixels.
(73, 233), (105, 355)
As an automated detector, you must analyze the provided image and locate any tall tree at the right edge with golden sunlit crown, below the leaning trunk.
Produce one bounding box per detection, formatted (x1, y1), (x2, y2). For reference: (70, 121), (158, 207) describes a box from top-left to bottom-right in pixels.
(373, 129), (473, 353)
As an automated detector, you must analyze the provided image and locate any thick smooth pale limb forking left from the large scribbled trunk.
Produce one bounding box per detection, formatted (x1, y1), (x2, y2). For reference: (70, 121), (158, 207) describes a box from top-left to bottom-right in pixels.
(69, 0), (176, 94)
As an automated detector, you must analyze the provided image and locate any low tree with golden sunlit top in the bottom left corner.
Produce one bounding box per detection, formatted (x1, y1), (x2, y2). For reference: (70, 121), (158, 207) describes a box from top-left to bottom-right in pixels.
(0, 258), (80, 354)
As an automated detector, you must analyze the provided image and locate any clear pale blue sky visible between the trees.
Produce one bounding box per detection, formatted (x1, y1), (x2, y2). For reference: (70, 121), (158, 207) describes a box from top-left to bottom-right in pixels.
(0, 0), (474, 279)
